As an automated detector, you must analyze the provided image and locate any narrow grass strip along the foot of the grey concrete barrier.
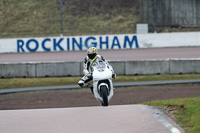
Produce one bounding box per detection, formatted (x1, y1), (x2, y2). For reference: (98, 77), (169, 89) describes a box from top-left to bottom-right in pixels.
(0, 74), (200, 89)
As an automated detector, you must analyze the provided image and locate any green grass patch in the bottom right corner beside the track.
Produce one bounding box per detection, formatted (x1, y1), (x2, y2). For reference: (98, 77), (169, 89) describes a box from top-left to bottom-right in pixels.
(145, 97), (200, 133)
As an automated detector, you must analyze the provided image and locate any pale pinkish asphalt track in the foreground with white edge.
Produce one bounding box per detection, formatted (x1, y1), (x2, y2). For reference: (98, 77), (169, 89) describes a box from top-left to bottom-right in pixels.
(0, 105), (183, 133)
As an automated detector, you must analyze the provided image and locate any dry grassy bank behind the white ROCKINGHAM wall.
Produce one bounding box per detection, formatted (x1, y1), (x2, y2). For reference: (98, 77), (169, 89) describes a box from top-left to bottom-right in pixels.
(0, 0), (139, 38)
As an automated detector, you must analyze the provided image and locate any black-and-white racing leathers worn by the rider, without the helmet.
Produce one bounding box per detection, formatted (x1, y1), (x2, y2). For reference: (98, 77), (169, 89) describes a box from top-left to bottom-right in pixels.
(78, 55), (114, 88)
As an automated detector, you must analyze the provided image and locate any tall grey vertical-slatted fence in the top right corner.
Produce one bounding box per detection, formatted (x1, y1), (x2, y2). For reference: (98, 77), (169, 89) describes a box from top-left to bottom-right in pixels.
(140, 0), (200, 26)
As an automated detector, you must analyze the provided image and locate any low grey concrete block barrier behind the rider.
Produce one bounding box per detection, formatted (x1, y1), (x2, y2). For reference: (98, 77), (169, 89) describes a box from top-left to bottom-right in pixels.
(0, 59), (200, 78)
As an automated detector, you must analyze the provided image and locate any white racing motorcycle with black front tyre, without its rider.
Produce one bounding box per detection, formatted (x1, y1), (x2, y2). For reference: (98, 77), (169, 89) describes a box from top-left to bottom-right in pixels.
(86, 62), (115, 106)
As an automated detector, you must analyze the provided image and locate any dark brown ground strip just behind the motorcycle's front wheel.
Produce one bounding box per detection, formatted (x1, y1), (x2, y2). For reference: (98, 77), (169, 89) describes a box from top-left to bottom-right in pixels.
(0, 84), (200, 110)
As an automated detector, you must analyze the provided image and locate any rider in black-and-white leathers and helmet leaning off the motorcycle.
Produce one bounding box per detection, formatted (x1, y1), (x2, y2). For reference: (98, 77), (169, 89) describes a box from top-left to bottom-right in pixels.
(78, 47), (116, 93)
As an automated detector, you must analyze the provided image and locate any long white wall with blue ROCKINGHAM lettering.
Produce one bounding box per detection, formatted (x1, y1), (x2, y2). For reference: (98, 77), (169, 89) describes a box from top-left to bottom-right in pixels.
(0, 32), (200, 53)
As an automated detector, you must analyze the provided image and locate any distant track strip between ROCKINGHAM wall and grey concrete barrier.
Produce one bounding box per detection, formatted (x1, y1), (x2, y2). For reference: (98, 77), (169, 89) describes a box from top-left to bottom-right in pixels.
(0, 47), (200, 63)
